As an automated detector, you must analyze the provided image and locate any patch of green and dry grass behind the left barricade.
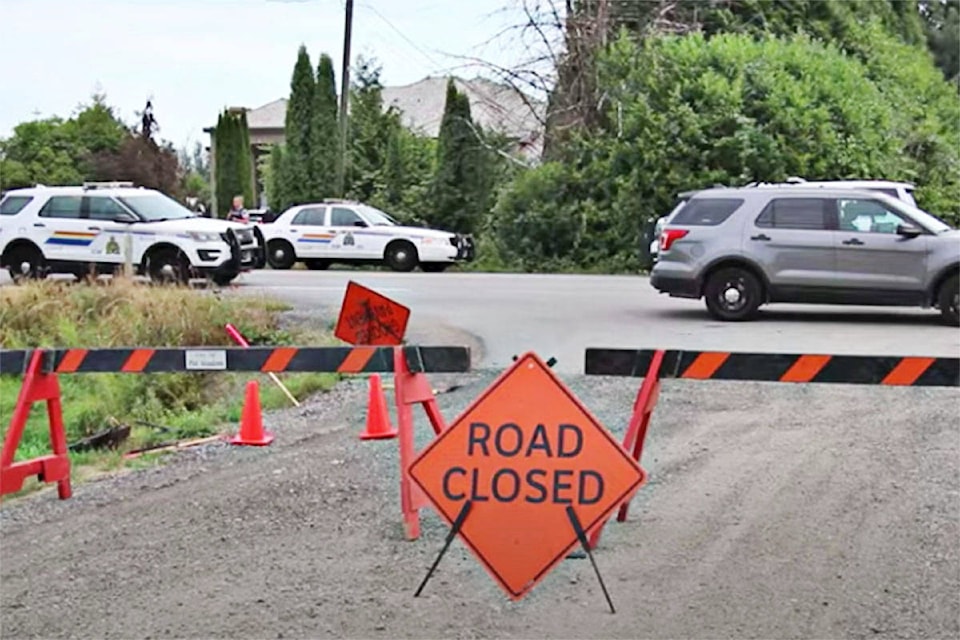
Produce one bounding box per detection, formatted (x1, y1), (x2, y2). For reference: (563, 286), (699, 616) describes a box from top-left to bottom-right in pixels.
(0, 278), (339, 496)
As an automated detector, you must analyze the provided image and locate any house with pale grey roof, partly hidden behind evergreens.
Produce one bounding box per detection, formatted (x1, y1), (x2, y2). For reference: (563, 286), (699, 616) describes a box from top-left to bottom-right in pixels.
(204, 76), (546, 210)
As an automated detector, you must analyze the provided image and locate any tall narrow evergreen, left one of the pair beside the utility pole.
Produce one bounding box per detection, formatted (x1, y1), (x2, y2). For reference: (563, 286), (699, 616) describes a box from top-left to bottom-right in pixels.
(280, 45), (317, 205)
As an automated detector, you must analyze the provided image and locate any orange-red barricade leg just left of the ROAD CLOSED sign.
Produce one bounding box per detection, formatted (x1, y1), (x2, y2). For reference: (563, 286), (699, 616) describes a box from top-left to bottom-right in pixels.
(393, 347), (447, 540)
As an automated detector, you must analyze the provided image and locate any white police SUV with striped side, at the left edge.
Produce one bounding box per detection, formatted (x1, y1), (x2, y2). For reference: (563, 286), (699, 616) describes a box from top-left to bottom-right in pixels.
(0, 182), (265, 285)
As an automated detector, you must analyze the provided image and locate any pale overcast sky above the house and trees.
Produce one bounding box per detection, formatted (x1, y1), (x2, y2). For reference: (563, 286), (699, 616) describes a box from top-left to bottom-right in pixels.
(0, 0), (562, 148)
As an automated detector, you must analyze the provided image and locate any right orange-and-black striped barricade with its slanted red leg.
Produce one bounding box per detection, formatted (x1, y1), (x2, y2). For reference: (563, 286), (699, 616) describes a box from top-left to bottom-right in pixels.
(584, 348), (960, 547)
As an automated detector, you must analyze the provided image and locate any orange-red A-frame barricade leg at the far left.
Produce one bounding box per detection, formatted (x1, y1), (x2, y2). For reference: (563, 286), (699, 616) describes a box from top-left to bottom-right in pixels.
(0, 350), (73, 500)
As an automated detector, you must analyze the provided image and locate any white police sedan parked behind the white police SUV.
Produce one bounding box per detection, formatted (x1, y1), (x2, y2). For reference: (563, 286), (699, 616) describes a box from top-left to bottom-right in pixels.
(261, 200), (475, 272)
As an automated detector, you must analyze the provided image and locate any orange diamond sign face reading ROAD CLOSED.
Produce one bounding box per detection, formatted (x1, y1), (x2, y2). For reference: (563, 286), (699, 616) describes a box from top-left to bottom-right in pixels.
(410, 353), (646, 600)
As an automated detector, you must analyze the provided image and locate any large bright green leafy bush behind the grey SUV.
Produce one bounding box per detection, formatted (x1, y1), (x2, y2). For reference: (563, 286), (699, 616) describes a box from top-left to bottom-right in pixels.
(492, 30), (960, 272)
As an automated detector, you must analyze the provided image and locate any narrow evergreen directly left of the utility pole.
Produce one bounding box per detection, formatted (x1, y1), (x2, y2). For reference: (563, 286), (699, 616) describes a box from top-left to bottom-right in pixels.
(310, 53), (340, 200)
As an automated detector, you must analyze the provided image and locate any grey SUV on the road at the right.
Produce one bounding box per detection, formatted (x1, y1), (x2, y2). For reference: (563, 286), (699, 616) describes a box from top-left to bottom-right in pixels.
(650, 186), (960, 326)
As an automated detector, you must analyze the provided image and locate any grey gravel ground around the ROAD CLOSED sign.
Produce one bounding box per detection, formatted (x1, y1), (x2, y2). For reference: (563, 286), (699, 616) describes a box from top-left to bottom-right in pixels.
(0, 362), (960, 639)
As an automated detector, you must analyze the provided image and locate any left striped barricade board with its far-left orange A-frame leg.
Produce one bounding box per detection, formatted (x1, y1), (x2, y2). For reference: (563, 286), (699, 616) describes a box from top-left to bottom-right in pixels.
(0, 346), (470, 499)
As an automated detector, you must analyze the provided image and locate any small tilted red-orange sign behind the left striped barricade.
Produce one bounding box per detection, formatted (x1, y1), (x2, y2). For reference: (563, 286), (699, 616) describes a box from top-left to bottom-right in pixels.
(333, 281), (410, 347)
